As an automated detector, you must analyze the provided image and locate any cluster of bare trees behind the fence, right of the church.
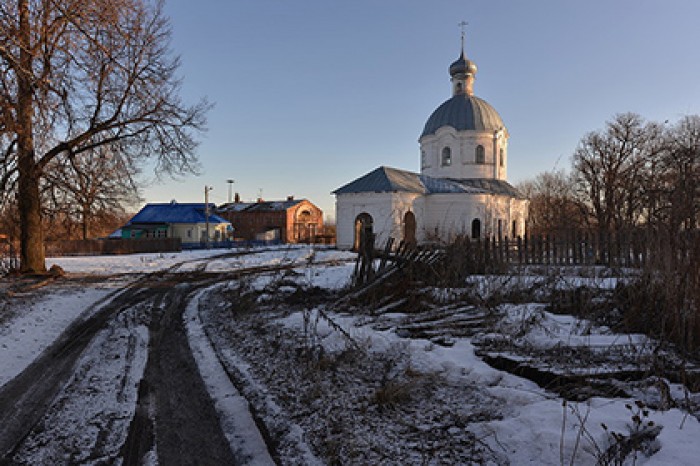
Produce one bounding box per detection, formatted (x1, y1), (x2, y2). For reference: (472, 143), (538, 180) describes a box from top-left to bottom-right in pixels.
(519, 113), (700, 248)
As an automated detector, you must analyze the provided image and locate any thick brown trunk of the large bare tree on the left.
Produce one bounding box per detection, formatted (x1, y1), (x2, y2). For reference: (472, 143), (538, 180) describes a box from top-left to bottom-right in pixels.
(17, 0), (46, 273)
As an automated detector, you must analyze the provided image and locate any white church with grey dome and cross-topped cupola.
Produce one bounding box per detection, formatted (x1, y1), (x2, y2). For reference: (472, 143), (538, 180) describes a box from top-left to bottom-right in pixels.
(333, 40), (528, 249)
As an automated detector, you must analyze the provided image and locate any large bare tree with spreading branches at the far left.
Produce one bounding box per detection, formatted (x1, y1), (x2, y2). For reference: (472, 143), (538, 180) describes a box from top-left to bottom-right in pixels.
(0, 0), (209, 272)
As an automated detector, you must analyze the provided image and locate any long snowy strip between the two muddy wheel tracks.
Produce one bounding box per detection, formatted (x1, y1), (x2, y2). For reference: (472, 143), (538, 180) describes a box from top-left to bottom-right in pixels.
(13, 300), (149, 464)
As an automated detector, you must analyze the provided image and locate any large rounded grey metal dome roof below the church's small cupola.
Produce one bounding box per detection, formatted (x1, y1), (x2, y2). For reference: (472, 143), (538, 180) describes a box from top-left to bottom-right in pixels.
(420, 94), (505, 138)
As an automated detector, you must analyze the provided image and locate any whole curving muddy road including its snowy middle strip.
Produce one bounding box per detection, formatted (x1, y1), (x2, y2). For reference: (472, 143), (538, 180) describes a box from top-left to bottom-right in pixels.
(0, 266), (291, 465)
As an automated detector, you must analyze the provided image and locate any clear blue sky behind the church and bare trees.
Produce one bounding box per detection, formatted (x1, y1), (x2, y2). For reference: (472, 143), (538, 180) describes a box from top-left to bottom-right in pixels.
(144, 0), (700, 222)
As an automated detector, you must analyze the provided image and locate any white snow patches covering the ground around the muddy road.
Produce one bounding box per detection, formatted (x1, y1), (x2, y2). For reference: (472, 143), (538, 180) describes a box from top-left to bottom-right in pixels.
(0, 247), (700, 466)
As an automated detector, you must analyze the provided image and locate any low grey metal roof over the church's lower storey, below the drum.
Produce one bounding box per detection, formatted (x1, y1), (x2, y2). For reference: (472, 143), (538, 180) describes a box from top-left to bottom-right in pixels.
(333, 167), (523, 199)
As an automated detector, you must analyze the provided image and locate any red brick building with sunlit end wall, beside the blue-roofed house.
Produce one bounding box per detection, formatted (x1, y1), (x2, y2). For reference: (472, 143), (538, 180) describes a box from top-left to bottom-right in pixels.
(217, 194), (323, 243)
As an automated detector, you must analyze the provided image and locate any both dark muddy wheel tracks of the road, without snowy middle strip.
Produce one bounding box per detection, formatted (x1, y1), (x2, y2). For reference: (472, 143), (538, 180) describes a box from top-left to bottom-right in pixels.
(0, 256), (334, 465)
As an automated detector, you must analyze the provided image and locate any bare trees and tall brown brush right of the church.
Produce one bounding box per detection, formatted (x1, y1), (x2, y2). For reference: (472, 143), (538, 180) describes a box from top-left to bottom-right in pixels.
(521, 113), (700, 359)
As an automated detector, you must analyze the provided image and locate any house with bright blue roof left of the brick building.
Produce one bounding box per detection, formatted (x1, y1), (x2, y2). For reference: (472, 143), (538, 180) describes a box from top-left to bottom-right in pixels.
(121, 201), (233, 248)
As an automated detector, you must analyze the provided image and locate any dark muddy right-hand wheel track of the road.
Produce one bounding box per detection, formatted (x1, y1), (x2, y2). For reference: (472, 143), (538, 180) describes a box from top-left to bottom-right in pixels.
(121, 280), (237, 465)
